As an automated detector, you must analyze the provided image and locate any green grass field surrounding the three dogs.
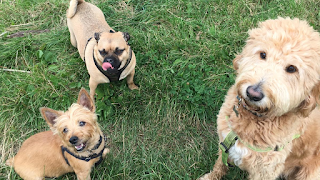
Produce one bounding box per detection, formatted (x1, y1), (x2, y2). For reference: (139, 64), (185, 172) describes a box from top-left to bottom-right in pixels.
(0, 0), (320, 180)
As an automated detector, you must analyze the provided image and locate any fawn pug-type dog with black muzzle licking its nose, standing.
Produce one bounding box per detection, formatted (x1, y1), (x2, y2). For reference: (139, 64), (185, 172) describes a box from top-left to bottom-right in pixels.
(67, 0), (138, 100)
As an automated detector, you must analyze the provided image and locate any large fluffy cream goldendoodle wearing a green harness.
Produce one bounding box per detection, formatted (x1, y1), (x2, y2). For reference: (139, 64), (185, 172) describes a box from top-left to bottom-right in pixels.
(200, 18), (320, 180)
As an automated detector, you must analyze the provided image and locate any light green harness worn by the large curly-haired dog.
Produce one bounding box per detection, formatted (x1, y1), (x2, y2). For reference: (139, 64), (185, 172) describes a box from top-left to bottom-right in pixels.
(219, 116), (300, 167)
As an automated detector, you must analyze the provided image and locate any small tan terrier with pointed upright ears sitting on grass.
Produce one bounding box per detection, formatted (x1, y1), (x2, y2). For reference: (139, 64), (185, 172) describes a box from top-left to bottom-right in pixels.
(6, 89), (109, 180)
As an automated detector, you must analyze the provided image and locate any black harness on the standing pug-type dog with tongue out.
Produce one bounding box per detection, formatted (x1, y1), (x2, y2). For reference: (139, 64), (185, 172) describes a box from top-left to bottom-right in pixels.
(92, 47), (132, 82)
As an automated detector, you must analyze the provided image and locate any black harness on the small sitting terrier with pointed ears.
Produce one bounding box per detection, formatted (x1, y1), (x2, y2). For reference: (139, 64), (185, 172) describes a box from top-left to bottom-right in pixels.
(61, 135), (105, 166)
